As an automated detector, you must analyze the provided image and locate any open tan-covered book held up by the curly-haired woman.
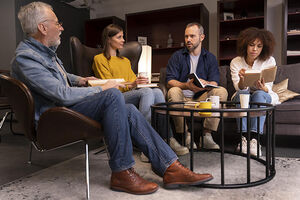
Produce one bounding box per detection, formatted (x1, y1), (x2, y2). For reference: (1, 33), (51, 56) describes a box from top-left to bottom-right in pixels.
(244, 66), (277, 87)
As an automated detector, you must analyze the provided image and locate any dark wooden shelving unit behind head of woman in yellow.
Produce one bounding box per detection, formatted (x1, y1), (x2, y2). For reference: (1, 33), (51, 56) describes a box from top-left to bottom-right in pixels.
(84, 16), (125, 48)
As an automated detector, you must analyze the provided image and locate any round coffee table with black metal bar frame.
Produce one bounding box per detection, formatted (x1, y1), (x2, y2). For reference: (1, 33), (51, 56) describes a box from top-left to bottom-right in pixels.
(151, 101), (276, 188)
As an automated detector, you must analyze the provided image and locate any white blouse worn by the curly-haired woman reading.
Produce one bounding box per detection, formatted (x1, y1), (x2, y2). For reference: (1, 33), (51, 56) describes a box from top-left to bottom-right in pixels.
(230, 56), (280, 105)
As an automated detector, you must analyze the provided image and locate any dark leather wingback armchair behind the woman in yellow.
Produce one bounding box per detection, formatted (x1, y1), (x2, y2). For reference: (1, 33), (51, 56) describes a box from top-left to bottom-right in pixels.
(70, 36), (142, 77)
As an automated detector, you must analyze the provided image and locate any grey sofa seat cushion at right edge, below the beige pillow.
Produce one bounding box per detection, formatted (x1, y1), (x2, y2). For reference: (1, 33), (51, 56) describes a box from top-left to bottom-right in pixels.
(275, 99), (300, 125)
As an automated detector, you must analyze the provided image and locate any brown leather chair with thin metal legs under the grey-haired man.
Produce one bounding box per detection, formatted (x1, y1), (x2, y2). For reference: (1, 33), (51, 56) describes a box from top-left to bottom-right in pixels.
(0, 74), (104, 199)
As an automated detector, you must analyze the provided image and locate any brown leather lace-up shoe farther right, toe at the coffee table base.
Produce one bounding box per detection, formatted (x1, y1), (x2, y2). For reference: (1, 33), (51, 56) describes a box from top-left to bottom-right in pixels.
(163, 160), (213, 189)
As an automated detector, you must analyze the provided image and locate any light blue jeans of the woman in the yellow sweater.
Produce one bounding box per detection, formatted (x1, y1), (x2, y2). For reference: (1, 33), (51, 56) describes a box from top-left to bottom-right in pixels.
(123, 88), (173, 139)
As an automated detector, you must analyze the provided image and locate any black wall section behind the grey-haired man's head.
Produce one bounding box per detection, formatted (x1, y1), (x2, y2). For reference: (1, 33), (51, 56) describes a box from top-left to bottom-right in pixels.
(15, 0), (90, 73)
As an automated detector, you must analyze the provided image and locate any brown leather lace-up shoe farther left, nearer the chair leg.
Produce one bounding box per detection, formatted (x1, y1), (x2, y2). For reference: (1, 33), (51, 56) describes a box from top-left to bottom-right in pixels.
(110, 168), (158, 194)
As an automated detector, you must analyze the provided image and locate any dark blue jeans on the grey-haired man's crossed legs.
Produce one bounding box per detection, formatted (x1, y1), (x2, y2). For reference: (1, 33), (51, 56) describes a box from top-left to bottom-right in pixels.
(69, 88), (178, 175)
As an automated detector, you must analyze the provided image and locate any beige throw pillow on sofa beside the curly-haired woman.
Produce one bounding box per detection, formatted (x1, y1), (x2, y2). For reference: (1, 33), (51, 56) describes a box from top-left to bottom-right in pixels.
(272, 79), (300, 103)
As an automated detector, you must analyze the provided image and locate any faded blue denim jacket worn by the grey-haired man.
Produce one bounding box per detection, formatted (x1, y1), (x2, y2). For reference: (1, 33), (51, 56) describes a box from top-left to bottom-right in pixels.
(11, 37), (102, 122)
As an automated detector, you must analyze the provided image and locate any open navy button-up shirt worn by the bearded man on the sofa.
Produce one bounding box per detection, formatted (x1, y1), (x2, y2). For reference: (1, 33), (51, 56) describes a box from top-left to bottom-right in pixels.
(166, 47), (220, 84)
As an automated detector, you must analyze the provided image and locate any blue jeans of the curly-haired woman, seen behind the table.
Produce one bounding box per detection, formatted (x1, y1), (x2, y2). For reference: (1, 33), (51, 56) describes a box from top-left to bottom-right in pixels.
(233, 90), (272, 134)
